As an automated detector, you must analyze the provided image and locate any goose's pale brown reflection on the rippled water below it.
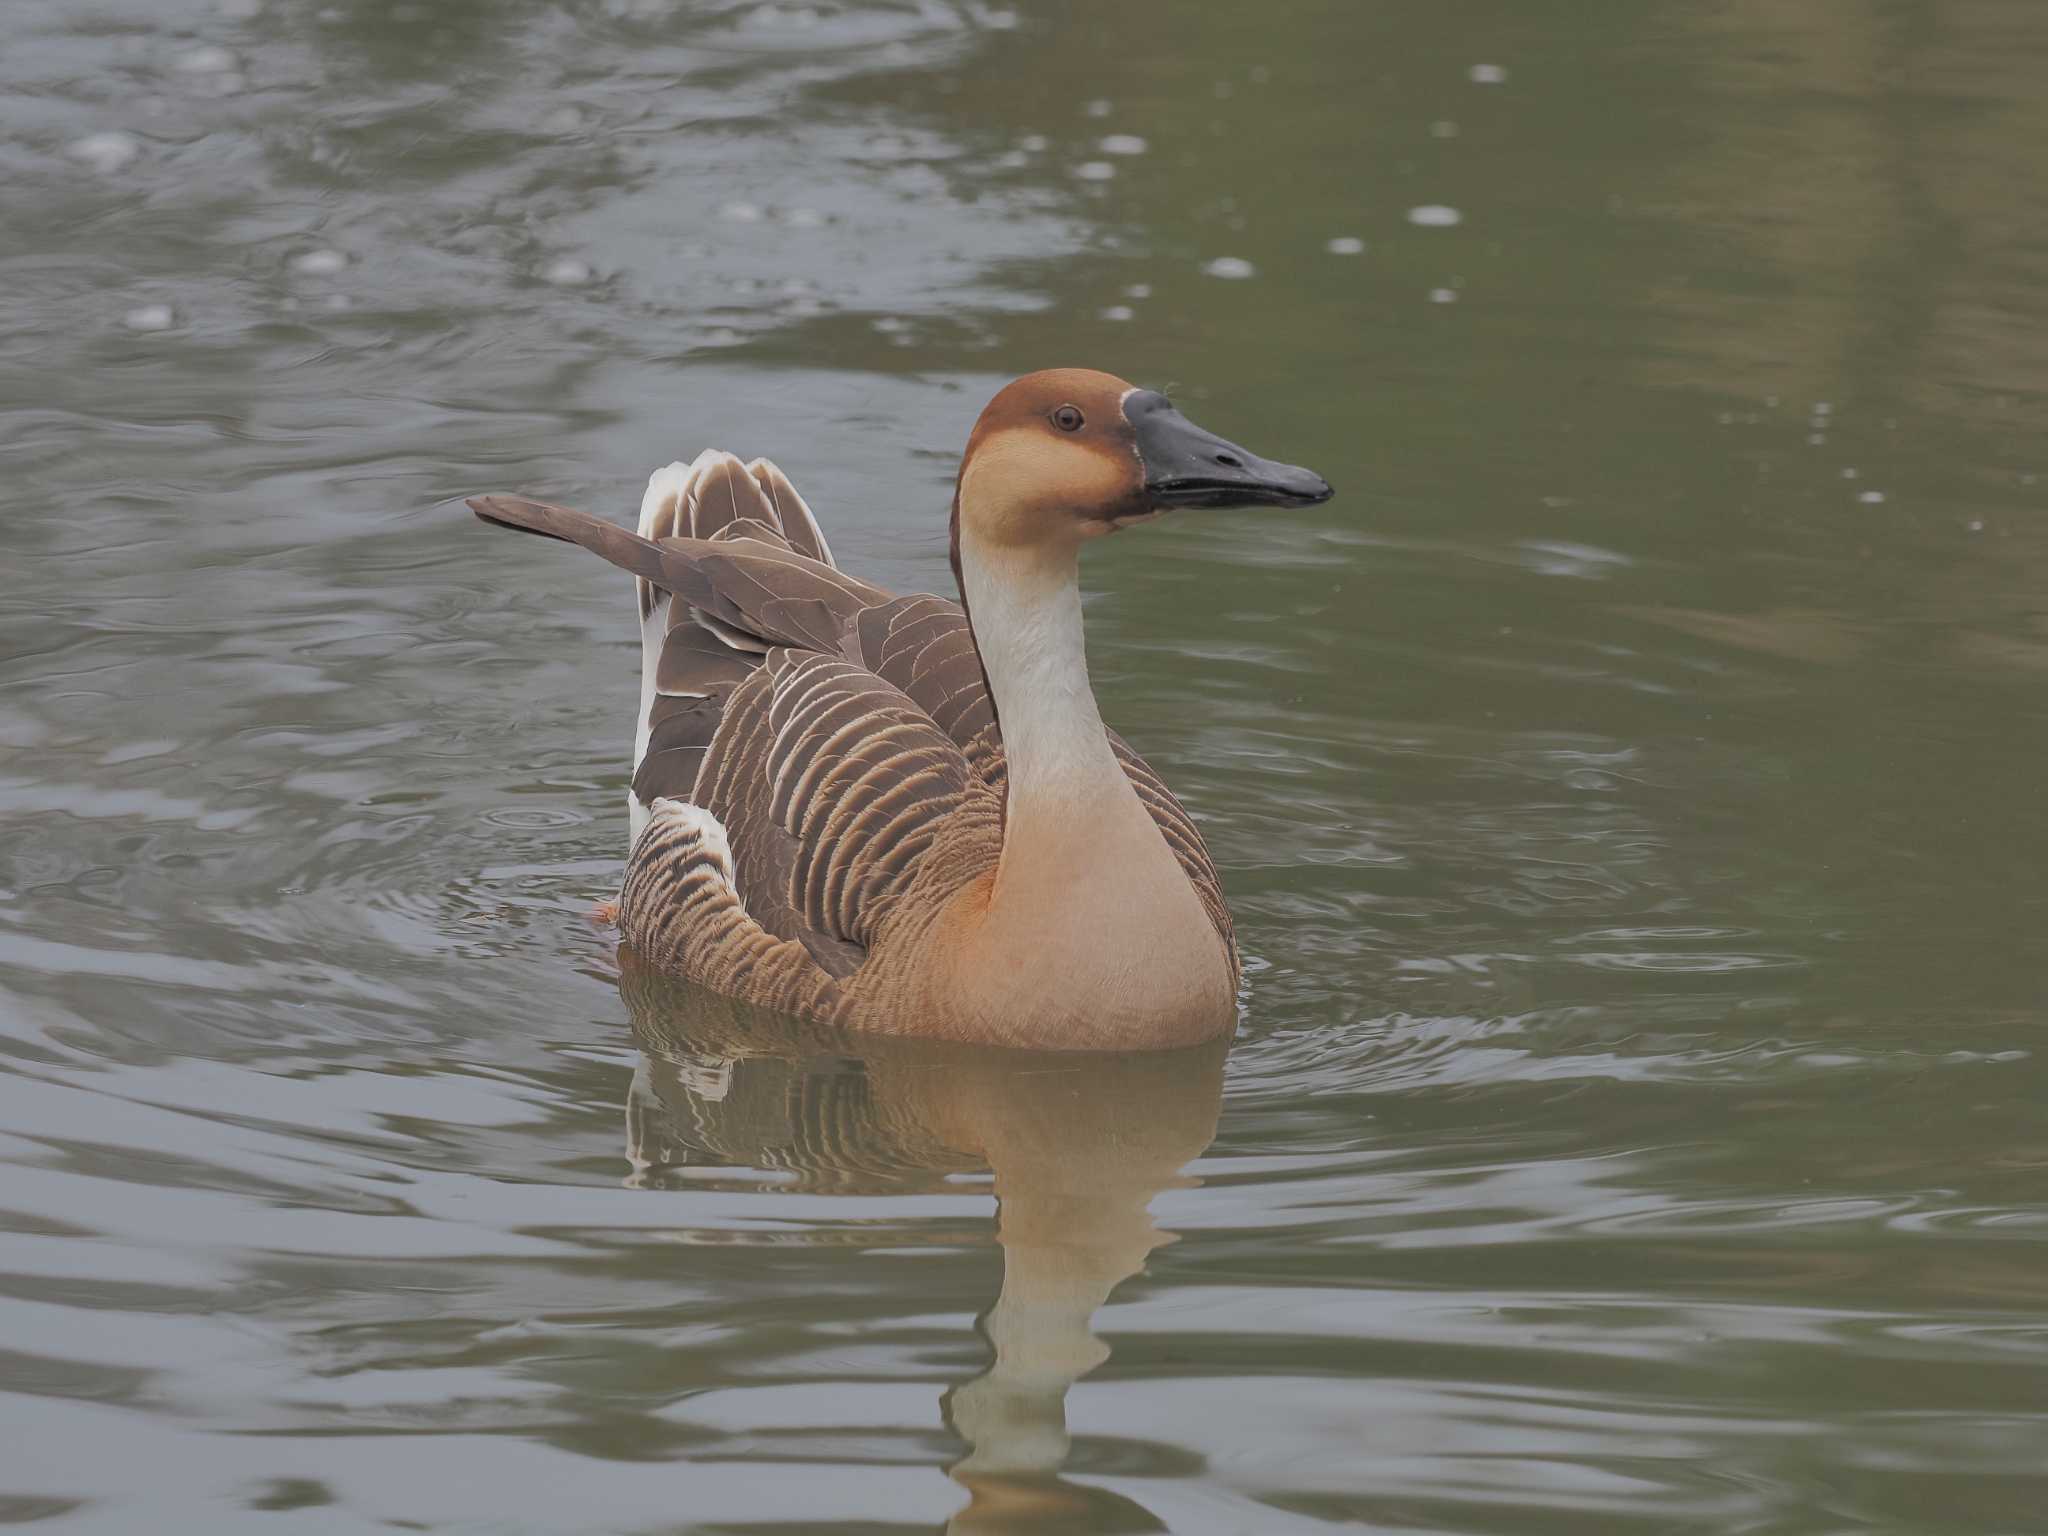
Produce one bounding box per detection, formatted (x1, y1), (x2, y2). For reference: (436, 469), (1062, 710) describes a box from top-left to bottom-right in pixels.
(621, 952), (1225, 1532)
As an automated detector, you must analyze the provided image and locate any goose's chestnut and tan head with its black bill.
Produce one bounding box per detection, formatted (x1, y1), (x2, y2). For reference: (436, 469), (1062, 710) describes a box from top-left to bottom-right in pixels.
(952, 369), (1331, 555)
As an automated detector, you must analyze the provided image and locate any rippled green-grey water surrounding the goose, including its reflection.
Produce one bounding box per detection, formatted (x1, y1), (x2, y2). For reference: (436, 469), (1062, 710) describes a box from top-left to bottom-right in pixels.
(0, 0), (2048, 1536)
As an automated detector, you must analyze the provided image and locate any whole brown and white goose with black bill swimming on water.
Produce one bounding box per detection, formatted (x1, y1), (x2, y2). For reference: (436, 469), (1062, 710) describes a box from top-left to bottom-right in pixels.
(471, 369), (1329, 1049)
